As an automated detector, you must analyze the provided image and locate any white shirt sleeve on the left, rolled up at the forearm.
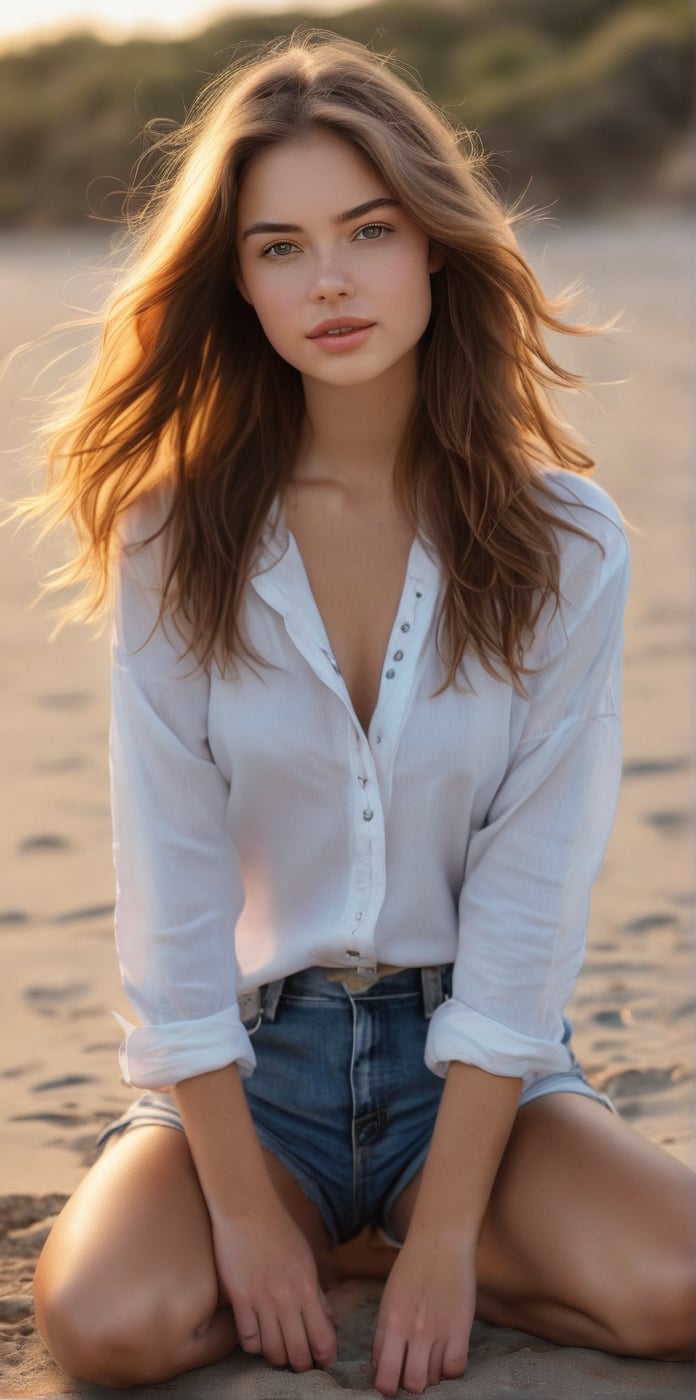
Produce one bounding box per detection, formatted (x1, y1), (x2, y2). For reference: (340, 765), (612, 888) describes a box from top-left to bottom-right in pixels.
(109, 498), (255, 1089)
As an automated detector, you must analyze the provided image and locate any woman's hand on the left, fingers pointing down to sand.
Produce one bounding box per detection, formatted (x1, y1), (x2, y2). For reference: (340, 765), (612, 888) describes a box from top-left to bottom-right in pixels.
(213, 1197), (336, 1371)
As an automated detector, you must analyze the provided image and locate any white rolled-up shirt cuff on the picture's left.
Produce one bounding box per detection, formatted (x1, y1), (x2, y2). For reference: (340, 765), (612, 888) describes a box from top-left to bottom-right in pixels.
(112, 1005), (256, 1091)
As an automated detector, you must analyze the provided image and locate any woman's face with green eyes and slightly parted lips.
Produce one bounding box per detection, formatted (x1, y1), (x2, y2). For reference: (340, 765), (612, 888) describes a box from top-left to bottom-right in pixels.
(237, 133), (441, 385)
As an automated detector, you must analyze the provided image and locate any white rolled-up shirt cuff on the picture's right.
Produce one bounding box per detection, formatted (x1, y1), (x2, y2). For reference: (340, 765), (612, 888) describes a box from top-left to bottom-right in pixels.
(426, 997), (570, 1085)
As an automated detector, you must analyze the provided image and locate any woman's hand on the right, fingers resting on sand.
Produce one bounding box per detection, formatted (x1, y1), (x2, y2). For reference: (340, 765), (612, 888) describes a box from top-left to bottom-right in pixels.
(373, 1228), (476, 1396)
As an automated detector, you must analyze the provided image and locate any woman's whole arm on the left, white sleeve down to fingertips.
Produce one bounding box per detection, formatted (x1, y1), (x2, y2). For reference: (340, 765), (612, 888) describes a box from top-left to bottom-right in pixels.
(111, 503), (336, 1369)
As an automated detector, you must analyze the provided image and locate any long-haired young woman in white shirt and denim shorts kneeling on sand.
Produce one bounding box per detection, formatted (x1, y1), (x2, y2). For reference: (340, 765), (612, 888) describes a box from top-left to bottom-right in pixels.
(24, 27), (696, 1396)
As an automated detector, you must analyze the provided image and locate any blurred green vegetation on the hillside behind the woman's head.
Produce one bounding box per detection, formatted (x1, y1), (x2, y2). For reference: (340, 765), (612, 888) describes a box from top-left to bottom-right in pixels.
(0, 0), (693, 227)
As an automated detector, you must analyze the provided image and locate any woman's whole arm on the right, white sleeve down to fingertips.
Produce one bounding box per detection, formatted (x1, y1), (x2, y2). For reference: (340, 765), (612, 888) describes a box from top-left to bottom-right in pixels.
(375, 503), (629, 1394)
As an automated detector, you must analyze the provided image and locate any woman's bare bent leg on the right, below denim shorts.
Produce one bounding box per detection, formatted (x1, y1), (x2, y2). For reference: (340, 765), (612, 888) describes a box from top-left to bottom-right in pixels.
(392, 1093), (696, 1359)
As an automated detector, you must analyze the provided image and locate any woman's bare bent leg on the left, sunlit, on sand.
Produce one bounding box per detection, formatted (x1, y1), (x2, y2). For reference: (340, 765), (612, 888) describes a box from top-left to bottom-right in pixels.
(34, 1126), (326, 1386)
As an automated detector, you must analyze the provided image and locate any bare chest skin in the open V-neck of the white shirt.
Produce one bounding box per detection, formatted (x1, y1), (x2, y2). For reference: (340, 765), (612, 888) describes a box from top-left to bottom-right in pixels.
(286, 492), (413, 734)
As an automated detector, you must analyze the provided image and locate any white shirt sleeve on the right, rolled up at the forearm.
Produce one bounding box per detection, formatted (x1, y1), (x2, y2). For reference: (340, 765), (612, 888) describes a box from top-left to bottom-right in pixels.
(426, 519), (629, 1084)
